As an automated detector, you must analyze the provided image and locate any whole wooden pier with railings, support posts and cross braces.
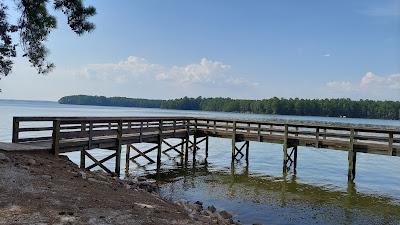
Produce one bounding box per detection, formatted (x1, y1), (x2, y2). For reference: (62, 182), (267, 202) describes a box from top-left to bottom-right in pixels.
(12, 117), (400, 181)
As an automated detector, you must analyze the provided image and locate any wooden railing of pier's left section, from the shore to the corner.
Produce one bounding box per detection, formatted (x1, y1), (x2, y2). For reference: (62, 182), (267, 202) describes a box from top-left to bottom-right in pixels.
(12, 117), (191, 153)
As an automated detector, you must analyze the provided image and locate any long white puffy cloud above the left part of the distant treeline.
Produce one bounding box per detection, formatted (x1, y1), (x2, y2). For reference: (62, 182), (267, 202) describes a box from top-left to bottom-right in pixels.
(78, 56), (256, 85)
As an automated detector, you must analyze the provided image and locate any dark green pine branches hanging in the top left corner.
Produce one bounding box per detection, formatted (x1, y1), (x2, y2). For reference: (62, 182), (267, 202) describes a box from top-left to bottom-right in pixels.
(0, 0), (96, 78)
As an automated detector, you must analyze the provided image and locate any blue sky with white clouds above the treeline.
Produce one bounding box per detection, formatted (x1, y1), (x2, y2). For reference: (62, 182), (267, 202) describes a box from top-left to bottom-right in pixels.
(0, 0), (400, 100)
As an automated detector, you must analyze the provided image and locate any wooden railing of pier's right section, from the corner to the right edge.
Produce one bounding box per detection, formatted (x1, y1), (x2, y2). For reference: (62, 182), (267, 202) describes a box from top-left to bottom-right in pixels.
(192, 118), (400, 155)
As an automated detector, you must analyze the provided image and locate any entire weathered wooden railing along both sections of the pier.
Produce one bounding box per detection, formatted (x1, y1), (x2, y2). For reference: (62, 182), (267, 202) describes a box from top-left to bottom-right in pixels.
(12, 117), (400, 155)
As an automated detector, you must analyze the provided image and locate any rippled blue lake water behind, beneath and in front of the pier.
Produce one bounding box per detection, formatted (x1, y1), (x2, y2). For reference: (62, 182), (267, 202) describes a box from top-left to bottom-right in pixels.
(0, 100), (400, 225)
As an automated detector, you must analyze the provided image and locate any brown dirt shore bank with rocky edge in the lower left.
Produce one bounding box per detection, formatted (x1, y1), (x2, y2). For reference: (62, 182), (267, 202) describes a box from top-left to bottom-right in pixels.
(0, 151), (238, 225)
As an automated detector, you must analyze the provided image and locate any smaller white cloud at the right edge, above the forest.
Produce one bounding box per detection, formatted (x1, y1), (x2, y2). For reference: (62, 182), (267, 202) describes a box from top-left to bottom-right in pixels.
(326, 72), (400, 98)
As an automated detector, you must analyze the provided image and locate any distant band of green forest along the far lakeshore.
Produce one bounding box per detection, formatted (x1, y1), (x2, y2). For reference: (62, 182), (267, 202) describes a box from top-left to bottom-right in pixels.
(58, 95), (400, 120)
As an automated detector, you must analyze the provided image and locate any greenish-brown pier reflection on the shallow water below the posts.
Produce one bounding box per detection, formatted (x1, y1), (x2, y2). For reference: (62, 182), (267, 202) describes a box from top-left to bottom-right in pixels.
(155, 156), (400, 224)
